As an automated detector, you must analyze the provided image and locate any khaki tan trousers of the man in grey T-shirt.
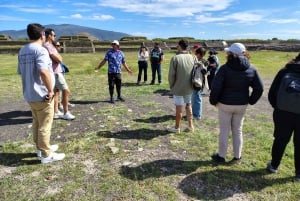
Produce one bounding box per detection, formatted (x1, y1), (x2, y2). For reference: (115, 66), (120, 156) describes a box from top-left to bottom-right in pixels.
(29, 100), (54, 157)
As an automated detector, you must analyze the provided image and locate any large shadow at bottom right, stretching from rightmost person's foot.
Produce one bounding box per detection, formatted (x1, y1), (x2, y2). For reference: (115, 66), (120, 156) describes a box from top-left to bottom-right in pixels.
(178, 169), (292, 200)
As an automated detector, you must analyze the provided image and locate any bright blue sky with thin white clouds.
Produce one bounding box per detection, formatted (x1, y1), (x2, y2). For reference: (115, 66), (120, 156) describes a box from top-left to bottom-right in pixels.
(0, 0), (300, 40)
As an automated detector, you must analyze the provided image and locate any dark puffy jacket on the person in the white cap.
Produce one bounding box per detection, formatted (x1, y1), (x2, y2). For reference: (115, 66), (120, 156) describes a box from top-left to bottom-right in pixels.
(209, 56), (263, 105)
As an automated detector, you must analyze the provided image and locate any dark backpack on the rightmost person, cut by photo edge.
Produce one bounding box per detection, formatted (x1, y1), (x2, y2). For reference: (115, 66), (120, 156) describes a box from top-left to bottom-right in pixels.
(277, 73), (300, 114)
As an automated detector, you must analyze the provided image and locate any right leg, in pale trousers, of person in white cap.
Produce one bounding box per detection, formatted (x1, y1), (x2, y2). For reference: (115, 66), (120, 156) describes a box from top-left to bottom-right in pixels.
(232, 105), (247, 159)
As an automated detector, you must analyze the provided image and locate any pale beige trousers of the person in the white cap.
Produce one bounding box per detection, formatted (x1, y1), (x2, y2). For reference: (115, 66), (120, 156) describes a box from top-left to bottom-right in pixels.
(217, 103), (247, 158)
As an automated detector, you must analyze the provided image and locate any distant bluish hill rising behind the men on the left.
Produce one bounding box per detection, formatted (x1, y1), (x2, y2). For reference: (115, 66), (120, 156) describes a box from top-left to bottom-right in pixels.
(0, 24), (130, 41)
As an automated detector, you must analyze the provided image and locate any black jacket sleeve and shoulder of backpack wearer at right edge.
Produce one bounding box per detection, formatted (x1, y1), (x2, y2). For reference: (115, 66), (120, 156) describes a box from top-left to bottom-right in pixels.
(268, 61), (300, 108)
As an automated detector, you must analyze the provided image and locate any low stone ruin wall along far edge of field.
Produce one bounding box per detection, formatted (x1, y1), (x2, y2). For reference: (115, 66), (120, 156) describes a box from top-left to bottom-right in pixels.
(0, 40), (300, 54)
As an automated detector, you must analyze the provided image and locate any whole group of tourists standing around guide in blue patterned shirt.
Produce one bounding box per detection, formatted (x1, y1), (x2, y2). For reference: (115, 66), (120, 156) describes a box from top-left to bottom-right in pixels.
(18, 24), (300, 181)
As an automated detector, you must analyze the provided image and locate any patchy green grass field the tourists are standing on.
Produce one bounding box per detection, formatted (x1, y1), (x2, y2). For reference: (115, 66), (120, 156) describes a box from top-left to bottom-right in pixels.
(0, 51), (300, 201)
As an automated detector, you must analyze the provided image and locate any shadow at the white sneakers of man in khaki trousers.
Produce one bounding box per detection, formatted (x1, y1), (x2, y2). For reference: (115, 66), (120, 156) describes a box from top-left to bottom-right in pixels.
(0, 153), (41, 167)
